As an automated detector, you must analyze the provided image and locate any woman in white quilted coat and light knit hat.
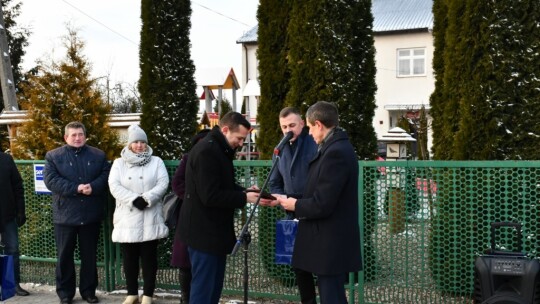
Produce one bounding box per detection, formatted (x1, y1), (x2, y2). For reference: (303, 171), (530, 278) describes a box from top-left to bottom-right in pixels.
(109, 125), (169, 304)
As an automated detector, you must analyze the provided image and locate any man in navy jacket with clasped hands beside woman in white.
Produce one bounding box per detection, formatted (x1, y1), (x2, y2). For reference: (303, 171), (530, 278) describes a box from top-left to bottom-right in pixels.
(44, 122), (110, 304)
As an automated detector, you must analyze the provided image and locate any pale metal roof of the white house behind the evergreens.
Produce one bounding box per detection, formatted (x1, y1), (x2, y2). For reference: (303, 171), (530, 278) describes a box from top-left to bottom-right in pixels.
(236, 0), (433, 44)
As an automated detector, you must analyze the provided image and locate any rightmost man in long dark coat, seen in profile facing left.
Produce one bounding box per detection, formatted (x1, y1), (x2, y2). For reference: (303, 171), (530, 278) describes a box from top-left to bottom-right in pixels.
(278, 101), (362, 304)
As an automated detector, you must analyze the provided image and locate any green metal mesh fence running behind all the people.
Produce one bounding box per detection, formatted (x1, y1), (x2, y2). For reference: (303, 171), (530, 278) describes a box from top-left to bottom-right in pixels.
(12, 161), (540, 303)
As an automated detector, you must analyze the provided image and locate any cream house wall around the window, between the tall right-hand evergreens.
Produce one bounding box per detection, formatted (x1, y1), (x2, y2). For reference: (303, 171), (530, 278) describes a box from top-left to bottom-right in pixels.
(373, 31), (435, 149)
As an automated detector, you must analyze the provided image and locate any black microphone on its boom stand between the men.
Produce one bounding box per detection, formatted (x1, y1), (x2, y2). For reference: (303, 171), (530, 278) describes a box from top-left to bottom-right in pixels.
(231, 149), (281, 304)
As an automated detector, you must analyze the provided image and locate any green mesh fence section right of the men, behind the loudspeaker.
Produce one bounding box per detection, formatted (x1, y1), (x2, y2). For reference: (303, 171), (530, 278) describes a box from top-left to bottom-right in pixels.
(360, 161), (540, 303)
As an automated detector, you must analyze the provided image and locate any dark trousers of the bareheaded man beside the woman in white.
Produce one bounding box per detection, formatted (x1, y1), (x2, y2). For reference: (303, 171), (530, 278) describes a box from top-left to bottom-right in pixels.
(54, 222), (101, 299)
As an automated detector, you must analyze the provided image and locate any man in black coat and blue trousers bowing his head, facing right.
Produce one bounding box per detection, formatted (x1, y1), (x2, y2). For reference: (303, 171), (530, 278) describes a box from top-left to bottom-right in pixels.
(178, 112), (270, 304)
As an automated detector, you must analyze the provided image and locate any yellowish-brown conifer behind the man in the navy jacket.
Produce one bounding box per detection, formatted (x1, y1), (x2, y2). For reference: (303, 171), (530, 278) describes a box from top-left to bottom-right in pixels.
(13, 29), (121, 159)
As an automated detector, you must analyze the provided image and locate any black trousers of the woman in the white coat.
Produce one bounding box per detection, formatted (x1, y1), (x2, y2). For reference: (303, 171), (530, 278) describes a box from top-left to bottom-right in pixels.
(121, 240), (158, 297)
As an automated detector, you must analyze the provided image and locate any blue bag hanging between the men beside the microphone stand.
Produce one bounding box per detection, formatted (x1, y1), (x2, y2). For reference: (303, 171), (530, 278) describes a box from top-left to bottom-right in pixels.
(274, 220), (298, 265)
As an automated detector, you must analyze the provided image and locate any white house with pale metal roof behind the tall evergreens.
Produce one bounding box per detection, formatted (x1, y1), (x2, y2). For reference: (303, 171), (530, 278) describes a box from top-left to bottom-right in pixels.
(237, 0), (435, 156)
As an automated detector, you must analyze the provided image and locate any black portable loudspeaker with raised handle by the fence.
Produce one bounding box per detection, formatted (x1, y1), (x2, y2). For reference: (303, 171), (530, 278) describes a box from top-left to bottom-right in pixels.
(473, 222), (540, 304)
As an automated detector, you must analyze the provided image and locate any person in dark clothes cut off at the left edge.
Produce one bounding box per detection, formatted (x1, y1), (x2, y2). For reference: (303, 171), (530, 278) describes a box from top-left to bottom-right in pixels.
(0, 152), (29, 296)
